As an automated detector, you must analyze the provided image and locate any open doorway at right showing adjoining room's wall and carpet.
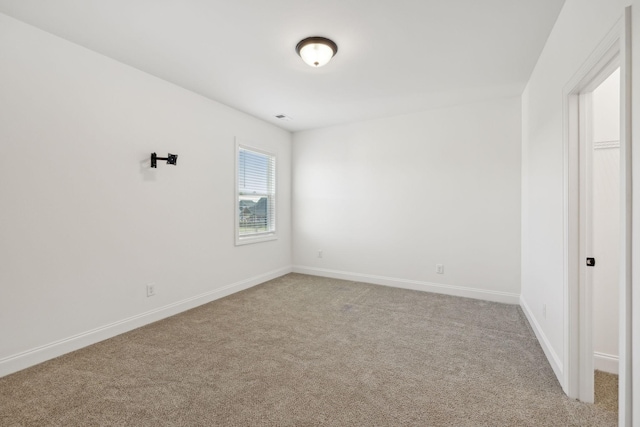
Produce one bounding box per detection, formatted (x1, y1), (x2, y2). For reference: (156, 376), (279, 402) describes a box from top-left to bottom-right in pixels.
(580, 67), (621, 408)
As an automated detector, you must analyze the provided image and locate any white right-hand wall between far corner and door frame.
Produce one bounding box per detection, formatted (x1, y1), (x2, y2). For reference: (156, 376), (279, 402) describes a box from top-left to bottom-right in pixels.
(522, 0), (627, 386)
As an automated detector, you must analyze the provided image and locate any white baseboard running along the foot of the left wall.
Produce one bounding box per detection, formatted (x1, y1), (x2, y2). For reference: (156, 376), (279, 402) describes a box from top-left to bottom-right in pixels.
(0, 266), (293, 377)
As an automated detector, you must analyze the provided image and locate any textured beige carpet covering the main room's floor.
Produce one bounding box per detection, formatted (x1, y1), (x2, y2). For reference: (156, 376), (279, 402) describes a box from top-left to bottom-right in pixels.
(0, 274), (617, 427)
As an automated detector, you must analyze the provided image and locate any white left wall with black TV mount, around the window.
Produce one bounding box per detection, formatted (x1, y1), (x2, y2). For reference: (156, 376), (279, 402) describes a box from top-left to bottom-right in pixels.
(0, 14), (291, 375)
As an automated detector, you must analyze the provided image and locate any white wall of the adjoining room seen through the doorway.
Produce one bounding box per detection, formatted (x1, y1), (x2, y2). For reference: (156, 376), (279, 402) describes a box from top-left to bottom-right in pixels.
(592, 70), (620, 374)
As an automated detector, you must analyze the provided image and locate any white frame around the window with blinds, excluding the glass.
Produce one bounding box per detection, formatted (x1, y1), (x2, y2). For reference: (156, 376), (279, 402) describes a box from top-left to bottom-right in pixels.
(233, 139), (278, 246)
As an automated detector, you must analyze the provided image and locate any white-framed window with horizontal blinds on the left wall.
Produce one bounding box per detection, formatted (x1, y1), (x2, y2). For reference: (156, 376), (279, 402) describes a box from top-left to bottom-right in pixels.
(235, 144), (276, 245)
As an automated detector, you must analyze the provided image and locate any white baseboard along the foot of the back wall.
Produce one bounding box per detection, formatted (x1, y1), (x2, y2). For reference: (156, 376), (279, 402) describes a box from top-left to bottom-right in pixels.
(293, 265), (520, 304)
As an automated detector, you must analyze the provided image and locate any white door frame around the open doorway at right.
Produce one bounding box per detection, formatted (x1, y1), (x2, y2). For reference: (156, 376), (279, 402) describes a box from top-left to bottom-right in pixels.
(563, 7), (632, 426)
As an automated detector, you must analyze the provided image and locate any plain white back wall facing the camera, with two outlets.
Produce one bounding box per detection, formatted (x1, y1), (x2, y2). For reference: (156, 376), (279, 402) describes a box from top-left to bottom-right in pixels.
(293, 98), (521, 303)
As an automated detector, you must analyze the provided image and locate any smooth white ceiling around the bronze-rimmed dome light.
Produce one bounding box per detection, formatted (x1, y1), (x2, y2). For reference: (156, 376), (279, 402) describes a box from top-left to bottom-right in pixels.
(0, 0), (564, 131)
